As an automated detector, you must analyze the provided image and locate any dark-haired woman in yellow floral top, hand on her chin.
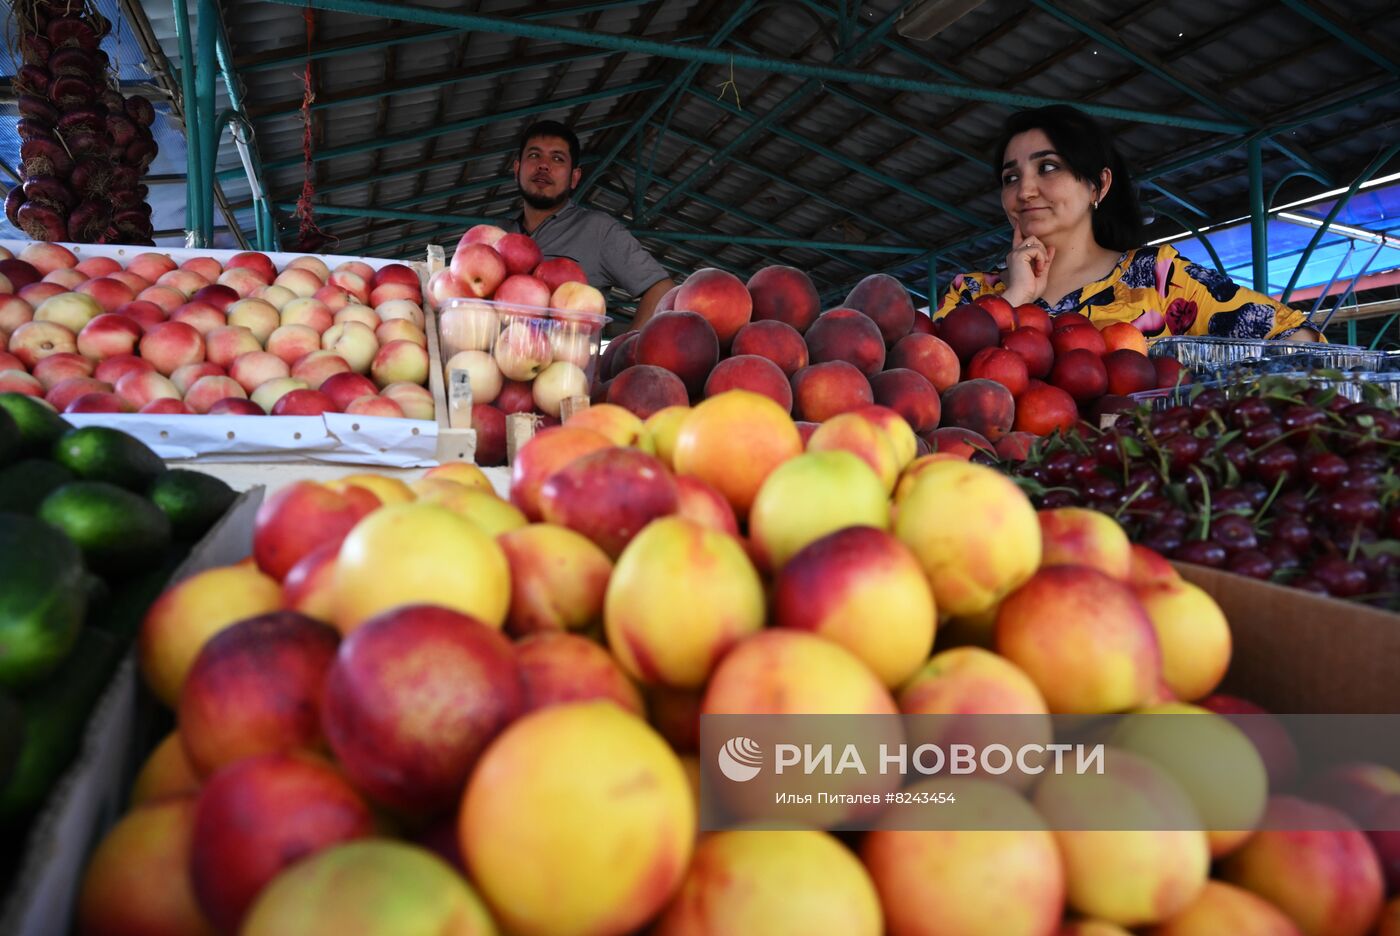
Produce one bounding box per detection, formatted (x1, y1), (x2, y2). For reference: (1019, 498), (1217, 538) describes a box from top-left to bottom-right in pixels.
(934, 105), (1320, 341)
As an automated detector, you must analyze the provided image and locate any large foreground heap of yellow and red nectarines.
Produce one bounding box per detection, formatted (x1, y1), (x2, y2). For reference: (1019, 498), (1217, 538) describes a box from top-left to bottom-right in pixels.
(78, 390), (1400, 936)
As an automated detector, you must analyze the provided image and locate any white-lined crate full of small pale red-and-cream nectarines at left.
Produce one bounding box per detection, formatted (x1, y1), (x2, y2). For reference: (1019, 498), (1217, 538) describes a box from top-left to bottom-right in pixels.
(0, 242), (470, 467)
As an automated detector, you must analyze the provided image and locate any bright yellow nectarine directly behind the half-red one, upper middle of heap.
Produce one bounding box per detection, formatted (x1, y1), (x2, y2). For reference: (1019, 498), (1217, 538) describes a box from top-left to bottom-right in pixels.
(749, 451), (889, 571)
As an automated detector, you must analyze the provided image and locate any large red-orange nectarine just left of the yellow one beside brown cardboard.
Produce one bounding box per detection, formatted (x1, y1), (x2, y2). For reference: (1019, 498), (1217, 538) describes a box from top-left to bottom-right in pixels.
(996, 565), (1162, 714)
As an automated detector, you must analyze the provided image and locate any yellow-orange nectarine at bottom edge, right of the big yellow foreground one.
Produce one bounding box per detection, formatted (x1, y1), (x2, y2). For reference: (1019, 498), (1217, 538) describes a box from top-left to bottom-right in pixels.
(654, 828), (885, 936)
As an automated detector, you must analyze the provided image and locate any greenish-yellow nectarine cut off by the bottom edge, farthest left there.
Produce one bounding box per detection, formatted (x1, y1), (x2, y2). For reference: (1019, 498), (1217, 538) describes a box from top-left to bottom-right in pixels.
(241, 839), (497, 936)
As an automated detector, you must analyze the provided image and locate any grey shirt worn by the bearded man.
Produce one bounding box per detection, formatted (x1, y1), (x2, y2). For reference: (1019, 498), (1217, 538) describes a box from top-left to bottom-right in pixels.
(501, 201), (668, 297)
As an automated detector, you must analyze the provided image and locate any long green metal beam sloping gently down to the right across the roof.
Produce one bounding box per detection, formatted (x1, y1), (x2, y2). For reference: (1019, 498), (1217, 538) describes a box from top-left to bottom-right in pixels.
(263, 0), (1249, 133)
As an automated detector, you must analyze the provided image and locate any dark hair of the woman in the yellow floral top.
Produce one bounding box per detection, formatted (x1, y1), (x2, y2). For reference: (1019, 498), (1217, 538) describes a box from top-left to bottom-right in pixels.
(993, 104), (1144, 250)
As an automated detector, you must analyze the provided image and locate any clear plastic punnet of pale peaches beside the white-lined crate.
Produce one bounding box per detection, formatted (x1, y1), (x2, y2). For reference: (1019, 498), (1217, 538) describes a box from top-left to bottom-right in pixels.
(438, 293), (608, 420)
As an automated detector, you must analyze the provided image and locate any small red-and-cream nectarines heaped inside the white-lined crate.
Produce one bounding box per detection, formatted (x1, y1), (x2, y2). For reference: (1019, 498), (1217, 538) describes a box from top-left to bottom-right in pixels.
(0, 243), (434, 420)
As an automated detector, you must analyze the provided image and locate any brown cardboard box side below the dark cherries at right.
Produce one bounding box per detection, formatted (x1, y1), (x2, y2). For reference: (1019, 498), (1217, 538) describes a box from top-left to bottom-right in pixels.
(1175, 562), (1400, 715)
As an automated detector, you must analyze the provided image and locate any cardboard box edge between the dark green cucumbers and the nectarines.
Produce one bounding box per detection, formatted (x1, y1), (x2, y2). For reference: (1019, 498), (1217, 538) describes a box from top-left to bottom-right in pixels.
(0, 488), (263, 936)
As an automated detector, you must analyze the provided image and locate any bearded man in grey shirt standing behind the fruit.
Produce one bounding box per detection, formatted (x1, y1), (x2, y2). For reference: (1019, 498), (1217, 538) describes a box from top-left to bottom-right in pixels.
(501, 120), (675, 327)
